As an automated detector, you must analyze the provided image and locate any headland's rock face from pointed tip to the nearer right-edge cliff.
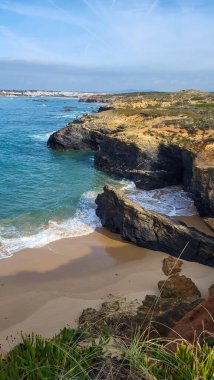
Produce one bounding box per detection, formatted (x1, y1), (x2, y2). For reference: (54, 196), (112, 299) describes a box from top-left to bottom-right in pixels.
(48, 119), (183, 190)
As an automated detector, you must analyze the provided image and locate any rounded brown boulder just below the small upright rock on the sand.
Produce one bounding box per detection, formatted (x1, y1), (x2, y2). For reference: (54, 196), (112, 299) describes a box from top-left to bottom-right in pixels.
(158, 274), (201, 299)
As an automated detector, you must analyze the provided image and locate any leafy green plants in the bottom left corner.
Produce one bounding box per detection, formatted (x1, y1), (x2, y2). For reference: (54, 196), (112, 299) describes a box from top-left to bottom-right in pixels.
(0, 328), (104, 380)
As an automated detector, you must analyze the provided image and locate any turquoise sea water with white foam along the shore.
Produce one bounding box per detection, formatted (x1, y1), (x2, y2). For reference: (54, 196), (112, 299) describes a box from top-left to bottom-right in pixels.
(0, 97), (196, 258)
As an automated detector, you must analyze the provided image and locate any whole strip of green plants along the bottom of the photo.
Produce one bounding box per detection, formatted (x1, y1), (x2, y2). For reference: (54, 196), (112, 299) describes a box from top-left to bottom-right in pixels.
(0, 328), (214, 380)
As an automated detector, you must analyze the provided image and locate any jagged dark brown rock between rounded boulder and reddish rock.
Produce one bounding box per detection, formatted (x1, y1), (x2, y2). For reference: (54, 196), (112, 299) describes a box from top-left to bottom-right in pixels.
(136, 295), (202, 336)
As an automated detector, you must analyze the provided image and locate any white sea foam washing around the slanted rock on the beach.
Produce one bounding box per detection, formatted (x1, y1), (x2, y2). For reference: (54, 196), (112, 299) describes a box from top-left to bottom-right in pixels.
(0, 180), (197, 259)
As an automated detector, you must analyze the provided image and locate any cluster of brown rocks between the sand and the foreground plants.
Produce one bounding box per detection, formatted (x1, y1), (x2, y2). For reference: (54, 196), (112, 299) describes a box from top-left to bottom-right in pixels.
(79, 276), (203, 338)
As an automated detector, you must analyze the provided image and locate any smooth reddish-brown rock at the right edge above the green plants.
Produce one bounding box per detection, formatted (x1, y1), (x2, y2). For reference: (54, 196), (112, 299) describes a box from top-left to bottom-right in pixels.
(169, 297), (214, 349)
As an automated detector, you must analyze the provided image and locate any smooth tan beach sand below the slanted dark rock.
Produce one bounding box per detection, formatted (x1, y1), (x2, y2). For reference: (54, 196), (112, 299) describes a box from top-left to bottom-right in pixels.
(0, 218), (214, 351)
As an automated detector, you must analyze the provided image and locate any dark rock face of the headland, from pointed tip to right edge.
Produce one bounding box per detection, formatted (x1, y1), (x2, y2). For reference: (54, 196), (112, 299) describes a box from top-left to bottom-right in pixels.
(48, 110), (214, 216)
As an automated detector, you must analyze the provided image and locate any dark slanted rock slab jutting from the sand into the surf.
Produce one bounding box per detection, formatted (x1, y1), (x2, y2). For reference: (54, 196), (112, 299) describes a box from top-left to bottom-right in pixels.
(96, 185), (214, 266)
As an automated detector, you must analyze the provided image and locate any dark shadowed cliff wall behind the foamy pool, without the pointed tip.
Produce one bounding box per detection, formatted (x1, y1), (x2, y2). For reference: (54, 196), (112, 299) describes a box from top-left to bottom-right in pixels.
(95, 135), (183, 190)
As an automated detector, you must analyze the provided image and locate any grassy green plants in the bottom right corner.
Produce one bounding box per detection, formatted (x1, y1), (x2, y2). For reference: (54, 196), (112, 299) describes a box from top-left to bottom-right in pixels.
(124, 338), (214, 380)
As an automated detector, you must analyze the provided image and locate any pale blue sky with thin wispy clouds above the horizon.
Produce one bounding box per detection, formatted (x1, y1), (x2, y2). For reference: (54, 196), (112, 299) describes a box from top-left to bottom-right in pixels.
(0, 0), (214, 92)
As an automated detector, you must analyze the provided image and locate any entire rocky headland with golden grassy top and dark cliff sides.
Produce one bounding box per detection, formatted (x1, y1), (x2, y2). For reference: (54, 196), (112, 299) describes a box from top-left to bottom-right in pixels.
(48, 92), (214, 217)
